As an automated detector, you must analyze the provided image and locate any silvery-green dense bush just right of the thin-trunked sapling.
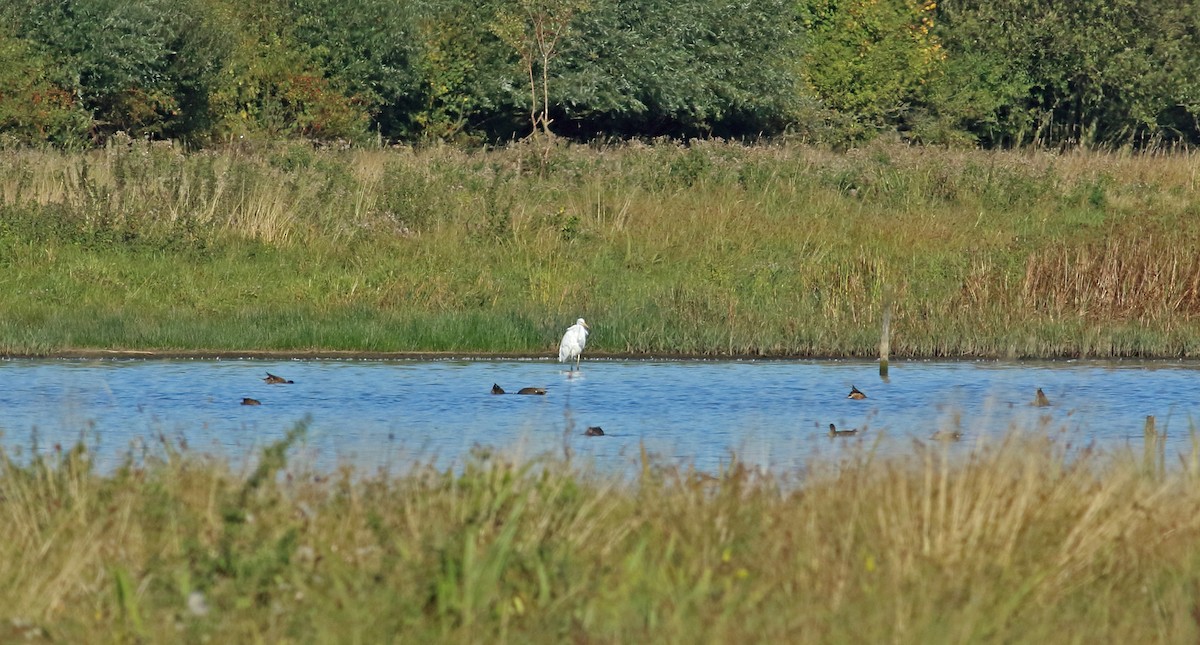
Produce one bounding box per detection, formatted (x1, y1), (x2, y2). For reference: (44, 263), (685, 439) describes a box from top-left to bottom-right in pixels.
(557, 0), (799, 137)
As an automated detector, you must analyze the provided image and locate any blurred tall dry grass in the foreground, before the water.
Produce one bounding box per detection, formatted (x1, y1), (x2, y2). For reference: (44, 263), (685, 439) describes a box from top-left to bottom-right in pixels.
(0, 424), (1200, 643)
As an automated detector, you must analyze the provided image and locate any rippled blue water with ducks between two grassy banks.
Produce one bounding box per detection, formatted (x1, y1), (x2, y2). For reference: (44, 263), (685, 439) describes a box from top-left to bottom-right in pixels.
(0, 360), (1200, 471)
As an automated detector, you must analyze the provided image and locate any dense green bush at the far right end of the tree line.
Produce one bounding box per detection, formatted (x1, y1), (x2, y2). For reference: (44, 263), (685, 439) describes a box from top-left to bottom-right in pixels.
(930, 0), (1200, 146)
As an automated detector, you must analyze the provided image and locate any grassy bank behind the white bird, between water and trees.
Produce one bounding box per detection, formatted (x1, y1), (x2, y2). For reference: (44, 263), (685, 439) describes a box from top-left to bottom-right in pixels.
(0, 136), (1200, 357)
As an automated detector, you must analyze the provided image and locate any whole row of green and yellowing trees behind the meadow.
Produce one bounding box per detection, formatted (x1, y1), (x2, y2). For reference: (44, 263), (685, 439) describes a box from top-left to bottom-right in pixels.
(0, 0), (1200, 147)
